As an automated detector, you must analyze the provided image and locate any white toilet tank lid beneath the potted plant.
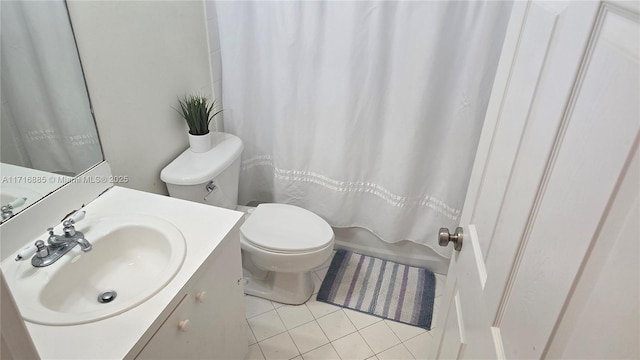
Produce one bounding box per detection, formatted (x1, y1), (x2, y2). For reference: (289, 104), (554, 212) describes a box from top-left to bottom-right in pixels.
(160, 132), (243, 185)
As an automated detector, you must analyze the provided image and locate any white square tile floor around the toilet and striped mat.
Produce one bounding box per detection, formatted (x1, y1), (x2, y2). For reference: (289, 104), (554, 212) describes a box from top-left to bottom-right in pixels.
(245, 253), (444, 360)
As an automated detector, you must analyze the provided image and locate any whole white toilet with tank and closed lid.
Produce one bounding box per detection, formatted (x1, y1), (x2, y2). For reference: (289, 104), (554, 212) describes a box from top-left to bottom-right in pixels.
(160, 133), (334, 304)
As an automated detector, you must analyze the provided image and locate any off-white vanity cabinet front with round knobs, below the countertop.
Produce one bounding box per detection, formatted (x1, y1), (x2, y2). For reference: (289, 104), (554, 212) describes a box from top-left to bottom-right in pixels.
(135, 233), (247, 360)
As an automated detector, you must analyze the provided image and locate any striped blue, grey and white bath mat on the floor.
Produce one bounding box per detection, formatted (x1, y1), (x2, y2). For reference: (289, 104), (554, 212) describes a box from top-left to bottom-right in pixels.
(317, 250), (436, 330)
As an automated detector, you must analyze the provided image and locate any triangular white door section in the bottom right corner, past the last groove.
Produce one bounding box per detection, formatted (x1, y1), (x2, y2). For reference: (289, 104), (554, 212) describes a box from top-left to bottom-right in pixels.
(545, 148), (640, 359)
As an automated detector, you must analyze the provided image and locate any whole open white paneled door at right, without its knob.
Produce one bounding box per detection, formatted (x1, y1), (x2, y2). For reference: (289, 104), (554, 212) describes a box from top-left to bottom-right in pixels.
(432, 1), (640, 359)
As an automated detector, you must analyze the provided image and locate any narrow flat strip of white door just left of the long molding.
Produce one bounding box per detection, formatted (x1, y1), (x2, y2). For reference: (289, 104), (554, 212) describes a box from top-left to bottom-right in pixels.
(486, 2), (598, 326)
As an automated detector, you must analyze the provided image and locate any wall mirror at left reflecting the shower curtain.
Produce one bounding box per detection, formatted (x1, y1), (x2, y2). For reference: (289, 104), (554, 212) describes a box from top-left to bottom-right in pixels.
(0, 0), (103, 221)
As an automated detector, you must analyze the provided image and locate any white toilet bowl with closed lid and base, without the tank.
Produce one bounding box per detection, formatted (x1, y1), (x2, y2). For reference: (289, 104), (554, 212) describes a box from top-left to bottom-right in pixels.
(240, 204), (334, 304)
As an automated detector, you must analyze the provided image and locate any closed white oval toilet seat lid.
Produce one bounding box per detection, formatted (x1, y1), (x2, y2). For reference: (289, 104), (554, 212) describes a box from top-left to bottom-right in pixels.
(240, 204), (334, 254)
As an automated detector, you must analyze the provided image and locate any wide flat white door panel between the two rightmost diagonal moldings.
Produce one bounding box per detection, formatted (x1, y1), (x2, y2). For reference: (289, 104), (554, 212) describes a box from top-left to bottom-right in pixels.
(499, 6), (640, 358)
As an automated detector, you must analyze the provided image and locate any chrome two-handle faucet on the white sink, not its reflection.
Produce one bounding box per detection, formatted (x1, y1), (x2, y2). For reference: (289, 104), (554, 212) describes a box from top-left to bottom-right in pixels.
(16, 211), (92, 267)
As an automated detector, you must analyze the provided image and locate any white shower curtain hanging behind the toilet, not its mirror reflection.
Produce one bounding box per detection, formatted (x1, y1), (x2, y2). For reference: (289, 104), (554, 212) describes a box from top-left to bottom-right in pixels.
(215, 1), (511, 256)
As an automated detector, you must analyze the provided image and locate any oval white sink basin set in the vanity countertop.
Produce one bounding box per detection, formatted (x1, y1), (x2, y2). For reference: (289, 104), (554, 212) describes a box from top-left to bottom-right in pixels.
(3, 215), (186, 325)
